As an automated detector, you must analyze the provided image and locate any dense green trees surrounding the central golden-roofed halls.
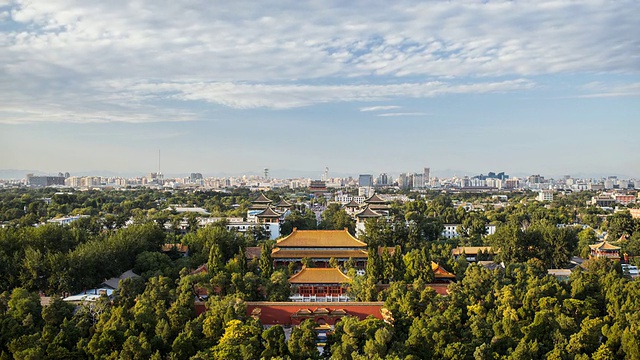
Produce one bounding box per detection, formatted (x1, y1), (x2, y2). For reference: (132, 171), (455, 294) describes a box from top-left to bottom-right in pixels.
(0, 189), (640, 359)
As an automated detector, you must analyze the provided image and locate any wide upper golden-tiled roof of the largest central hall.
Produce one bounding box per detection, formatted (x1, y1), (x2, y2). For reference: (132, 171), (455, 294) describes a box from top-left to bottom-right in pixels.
(276, 228), (367, 248)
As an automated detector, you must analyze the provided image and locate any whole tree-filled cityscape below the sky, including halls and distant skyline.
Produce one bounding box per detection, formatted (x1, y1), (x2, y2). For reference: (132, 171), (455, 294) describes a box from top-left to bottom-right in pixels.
(0, 168), (640, 359)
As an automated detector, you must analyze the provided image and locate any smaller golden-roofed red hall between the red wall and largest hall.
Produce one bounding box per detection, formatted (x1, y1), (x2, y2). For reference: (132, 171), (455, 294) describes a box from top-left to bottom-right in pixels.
(289, 267), (351, 302)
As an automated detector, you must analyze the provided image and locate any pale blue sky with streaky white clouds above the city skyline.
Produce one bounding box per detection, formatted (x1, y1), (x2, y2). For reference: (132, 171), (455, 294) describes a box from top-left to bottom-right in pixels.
(0, 0), (640, 178)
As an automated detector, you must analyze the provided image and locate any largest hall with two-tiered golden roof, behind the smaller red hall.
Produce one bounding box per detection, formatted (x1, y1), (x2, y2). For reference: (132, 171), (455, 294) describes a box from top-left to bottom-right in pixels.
(271, 228), (367, 269)
